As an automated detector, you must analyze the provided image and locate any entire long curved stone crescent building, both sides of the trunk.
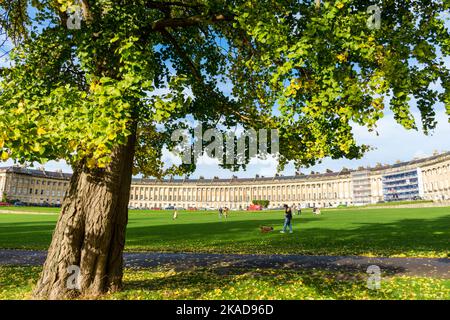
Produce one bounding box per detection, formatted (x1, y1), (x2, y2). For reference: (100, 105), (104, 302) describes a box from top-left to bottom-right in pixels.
(0, 152), (450, 209)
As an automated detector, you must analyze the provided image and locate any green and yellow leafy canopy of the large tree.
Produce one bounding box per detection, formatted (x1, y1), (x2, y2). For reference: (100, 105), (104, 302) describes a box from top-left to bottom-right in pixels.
(0, 0), (450, 177)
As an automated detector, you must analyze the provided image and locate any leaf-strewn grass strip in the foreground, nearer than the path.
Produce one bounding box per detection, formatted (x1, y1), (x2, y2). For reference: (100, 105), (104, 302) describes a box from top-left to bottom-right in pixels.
(0, 267), (450, 300)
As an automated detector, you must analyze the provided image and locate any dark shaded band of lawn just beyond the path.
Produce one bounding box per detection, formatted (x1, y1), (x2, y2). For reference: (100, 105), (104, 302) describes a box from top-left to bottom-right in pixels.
(0, 215), (450, 257)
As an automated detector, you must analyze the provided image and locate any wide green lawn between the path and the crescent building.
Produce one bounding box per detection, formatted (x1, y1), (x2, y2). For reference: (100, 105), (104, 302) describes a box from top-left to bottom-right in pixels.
(0, 208), (450, 257)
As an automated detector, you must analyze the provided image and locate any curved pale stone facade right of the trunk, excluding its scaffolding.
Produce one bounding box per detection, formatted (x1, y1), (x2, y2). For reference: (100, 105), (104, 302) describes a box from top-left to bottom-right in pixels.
(130, 153), (450, 209)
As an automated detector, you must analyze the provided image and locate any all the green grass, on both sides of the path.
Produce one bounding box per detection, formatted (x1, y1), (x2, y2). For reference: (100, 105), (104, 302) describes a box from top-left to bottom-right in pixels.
(0, 208), (450, 300)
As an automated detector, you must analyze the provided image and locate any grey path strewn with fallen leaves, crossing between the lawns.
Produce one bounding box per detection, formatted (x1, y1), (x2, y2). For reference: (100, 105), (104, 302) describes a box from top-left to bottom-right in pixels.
(0, 249), (450, 279)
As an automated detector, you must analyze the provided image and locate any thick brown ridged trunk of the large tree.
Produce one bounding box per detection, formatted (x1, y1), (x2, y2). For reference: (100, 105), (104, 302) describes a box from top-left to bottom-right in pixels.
(34, 130), (136, 299)
